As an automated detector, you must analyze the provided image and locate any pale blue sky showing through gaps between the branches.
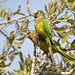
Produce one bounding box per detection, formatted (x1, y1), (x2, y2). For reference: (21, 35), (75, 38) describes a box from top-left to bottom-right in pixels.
(0, 0), (73, 71)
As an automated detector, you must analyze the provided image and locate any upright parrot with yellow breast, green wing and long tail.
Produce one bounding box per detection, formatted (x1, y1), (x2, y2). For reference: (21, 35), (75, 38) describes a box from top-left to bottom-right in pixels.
(33, 10), (75, 63)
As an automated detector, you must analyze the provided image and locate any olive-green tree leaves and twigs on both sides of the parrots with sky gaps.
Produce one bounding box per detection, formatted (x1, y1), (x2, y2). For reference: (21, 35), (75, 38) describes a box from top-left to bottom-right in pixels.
(0, 0), (75, 75)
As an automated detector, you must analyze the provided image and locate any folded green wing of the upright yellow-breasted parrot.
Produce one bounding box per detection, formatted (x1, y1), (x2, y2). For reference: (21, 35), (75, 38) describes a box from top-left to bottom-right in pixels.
(43, 19), (54, 45)
